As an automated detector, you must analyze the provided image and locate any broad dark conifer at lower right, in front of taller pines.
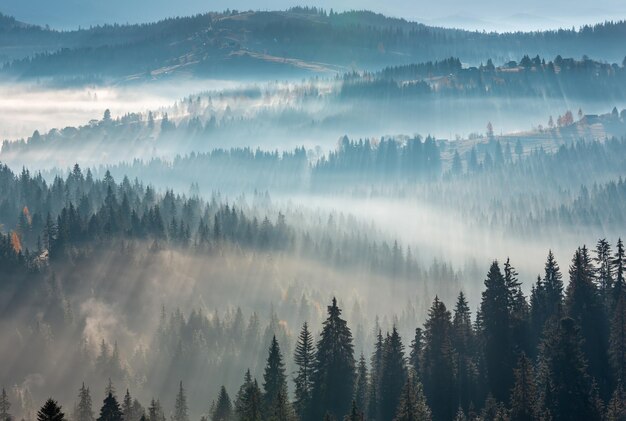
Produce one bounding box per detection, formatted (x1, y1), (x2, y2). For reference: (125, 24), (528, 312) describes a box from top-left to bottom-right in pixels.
(540, 318), (596, 421)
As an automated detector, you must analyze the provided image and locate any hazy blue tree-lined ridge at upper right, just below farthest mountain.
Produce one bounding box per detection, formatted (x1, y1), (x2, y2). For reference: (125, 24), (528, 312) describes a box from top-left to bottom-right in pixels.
(340, 55), (626, 101)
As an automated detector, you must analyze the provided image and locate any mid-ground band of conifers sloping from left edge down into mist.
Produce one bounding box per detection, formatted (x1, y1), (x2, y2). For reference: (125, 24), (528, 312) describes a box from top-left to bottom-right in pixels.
(0, 158), (457, 284)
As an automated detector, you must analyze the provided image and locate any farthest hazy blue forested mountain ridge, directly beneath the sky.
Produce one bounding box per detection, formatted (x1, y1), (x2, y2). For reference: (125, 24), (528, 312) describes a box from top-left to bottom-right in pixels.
(0, 7), (626, 82)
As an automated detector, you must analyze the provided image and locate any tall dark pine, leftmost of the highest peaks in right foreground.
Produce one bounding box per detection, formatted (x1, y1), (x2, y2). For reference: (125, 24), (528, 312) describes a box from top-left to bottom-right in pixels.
(480, 261), (513, 402)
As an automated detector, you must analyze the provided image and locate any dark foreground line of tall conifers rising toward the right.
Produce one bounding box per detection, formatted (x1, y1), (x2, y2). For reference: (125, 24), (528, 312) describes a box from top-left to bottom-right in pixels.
(7, 240), (626, 421)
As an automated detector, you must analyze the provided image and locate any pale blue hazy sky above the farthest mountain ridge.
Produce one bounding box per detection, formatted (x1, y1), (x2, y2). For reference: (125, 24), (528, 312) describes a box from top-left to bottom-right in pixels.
(0, 0), (626, 31)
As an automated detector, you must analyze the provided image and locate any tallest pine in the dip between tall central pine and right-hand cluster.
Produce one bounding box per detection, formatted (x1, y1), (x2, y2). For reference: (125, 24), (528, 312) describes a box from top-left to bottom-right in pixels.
(380, 326), (407, 421)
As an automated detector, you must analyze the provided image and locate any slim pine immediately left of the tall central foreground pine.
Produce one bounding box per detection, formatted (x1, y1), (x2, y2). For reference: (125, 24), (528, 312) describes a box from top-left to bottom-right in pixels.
(294, 322), (315, 419)
